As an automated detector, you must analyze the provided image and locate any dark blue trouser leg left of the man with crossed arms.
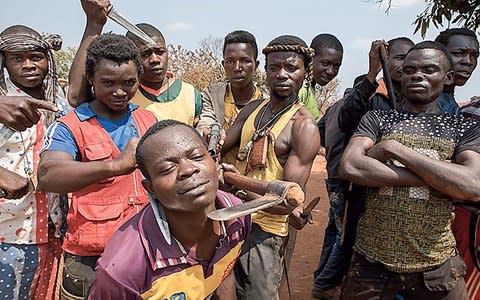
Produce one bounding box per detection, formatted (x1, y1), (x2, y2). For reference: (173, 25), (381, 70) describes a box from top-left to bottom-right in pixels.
(314, 179), (347, 290)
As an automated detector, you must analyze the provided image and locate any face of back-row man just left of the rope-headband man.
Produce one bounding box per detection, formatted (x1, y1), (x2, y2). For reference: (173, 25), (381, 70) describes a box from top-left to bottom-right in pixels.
(222, 43), (258, 87)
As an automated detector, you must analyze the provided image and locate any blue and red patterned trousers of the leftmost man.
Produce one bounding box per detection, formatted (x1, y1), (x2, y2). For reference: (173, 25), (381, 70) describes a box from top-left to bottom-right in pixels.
(0, 226), (62, 300)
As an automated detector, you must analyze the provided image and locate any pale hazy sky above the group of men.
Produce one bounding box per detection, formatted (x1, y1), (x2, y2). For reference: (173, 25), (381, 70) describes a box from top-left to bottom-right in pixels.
(0, 0), (480, 102)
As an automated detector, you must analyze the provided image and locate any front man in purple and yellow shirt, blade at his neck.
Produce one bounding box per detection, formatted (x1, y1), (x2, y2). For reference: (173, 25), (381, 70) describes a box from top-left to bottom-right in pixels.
(90, 120), (303, 300)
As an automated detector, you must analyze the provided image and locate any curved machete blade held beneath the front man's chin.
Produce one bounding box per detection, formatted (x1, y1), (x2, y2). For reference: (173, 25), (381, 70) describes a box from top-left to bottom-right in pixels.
(207, 196), (284, 221)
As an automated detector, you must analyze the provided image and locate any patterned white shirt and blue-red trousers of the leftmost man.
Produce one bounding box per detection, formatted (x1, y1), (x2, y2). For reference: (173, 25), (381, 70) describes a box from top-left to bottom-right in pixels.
(0, 79), (68, 300)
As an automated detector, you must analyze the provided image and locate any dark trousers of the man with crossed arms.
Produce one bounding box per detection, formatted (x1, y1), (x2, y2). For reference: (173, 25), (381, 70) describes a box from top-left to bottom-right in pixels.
(340, 252), (468, 300)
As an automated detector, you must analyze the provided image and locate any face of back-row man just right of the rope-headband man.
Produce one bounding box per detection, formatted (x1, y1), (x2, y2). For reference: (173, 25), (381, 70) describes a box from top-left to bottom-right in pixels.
(313, 47), (343, 86)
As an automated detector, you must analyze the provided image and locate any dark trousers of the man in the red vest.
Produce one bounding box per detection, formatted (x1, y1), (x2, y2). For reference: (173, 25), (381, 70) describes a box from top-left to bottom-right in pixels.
(60, 252), (100, 300)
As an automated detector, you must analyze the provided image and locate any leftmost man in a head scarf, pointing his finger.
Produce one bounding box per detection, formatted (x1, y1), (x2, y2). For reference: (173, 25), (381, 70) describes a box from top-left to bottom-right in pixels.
(0, 25), (68, 299)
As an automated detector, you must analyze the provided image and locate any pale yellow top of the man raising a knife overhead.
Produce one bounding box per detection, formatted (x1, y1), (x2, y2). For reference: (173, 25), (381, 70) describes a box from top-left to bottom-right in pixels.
(132, 82), (195, 126)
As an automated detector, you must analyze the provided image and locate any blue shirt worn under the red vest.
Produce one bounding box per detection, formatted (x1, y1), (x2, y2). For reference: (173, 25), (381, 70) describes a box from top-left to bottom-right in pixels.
(42, 102), (138, 161)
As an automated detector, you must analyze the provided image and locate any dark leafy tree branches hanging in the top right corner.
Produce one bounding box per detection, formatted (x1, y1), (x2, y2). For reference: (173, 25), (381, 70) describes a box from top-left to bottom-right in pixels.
(376, 0), (480, 38)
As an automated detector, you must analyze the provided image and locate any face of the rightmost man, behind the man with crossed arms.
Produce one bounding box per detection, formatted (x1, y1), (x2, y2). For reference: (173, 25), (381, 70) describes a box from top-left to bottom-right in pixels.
(446, 35), (478, 86)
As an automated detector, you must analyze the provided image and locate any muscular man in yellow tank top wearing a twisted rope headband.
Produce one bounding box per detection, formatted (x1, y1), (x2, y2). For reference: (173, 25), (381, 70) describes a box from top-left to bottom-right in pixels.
(222, 35), (320, 299)
